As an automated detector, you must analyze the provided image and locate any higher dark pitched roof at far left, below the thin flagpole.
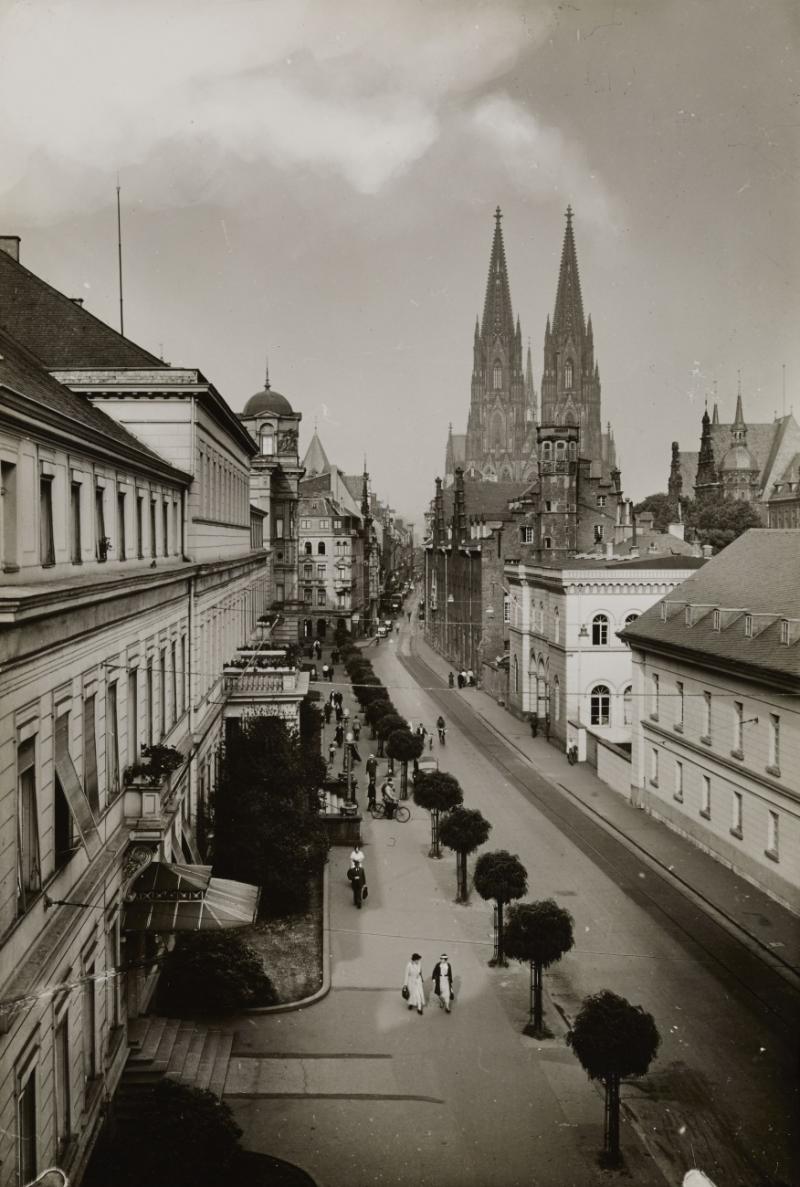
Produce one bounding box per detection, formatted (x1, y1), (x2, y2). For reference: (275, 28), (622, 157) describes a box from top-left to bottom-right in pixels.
(0, 250), (166, 369)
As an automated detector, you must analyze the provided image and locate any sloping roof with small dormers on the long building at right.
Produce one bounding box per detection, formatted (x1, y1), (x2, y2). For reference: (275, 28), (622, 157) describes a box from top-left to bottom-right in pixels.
(621, 528), (800, 688)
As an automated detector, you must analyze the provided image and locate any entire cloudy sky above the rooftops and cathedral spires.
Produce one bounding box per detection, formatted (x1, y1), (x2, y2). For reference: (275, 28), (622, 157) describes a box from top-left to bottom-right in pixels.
(0, 0), (800, 528)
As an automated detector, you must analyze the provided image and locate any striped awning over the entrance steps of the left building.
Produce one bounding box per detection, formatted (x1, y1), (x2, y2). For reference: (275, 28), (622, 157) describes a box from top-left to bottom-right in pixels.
(122, 862), (261, 932)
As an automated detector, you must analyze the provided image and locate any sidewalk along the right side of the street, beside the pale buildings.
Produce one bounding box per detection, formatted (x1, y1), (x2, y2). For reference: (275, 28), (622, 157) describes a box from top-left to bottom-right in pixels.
(412, 630), (800, 989)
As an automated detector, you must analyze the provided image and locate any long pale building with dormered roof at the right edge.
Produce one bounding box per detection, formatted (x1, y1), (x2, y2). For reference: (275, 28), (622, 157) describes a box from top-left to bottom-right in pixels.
(622, 529), (800, 910)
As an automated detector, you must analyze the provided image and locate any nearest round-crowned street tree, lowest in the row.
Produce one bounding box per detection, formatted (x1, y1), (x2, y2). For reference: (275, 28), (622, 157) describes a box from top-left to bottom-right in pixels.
(566, 989), (661, 1163)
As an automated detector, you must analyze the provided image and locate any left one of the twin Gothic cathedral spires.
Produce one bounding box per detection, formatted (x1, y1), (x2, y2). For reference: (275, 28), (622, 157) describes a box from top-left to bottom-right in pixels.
(463, 207), (535, 482)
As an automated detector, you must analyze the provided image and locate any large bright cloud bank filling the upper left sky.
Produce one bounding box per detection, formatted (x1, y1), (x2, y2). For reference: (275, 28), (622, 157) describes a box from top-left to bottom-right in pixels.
(0, 0), (546, 221)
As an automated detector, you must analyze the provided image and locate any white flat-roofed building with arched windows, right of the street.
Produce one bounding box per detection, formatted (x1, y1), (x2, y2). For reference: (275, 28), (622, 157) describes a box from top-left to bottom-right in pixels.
(504, 556), (703, 766)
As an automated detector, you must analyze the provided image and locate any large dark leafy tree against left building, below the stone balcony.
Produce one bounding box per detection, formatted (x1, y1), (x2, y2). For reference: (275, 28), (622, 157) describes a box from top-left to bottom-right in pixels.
(212, 717), (328, 914)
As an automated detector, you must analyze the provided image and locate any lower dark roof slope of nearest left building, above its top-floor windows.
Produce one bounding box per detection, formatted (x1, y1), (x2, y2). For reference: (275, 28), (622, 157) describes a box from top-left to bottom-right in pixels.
(0, 325), (189, 482)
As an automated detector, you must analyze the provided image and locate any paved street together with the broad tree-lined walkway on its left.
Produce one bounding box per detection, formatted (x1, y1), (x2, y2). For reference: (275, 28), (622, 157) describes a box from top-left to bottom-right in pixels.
(226, 627), (794, 1187)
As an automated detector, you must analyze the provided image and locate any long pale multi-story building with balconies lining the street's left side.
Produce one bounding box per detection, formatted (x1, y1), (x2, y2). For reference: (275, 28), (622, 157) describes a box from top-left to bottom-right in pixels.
(0, 237), (294, 1187)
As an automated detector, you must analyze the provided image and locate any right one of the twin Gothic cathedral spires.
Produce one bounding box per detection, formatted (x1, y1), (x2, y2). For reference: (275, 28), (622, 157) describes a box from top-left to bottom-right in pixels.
(541, 207), (600, 476)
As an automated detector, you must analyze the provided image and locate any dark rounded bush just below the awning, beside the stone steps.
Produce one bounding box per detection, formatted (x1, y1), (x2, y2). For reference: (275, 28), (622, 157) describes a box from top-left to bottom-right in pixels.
(158, 932), (275, 1017)
